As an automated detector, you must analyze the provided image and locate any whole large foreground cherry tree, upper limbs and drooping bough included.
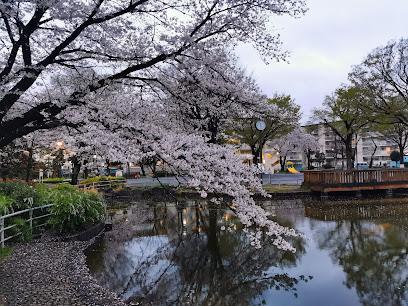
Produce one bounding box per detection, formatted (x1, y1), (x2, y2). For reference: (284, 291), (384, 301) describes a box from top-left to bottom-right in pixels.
(0, 0), (305, 251)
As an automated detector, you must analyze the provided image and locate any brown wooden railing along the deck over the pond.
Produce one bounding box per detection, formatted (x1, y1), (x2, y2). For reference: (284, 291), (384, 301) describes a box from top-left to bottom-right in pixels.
(304, 169), (408, 186)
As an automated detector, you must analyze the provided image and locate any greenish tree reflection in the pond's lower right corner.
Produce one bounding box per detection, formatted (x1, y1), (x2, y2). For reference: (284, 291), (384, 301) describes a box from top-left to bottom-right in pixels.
(318, 221), (408, 306)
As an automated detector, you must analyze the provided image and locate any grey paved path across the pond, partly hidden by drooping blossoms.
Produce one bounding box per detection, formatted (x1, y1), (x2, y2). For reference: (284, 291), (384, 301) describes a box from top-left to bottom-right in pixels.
(127, 173), (303, 187)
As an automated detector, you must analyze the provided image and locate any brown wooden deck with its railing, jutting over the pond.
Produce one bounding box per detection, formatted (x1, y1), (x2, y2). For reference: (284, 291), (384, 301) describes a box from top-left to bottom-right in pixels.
(304, 169), (408, 193)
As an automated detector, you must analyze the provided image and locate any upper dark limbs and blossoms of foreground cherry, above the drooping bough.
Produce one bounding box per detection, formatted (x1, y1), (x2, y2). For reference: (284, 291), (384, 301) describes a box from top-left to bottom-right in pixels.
(0, 0), (305, 146)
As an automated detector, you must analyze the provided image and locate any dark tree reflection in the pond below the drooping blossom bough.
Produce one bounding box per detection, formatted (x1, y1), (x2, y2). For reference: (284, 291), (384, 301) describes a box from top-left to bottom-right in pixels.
(87, 201), (304, 305)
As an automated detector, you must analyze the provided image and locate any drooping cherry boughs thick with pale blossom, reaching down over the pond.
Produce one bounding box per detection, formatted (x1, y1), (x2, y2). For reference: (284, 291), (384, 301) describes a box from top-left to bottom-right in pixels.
(53, 84), (297, 251)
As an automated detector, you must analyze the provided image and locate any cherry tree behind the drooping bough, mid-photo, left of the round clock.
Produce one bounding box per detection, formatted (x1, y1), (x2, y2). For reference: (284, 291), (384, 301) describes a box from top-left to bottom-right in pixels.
(157, 49), (268, 143)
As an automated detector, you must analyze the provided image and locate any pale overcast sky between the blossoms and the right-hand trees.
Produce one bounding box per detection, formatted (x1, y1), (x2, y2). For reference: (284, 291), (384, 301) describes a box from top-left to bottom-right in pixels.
(237, 0), (408, 122)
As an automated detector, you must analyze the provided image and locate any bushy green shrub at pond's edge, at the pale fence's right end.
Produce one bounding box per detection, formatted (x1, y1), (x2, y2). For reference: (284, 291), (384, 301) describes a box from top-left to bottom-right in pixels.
(44, 185), (105, 233)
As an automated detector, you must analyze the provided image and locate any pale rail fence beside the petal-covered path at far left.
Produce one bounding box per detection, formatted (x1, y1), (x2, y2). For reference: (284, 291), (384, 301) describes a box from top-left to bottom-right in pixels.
(0, 204), (53, 248)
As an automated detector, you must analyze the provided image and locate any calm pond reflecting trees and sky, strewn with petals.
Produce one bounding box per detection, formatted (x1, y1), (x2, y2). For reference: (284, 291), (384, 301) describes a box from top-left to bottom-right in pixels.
(87, 199), (408, 306)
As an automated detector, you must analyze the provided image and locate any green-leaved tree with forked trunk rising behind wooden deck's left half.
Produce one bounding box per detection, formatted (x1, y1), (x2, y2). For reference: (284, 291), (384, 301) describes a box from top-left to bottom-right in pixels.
(313, 86), (371, 169)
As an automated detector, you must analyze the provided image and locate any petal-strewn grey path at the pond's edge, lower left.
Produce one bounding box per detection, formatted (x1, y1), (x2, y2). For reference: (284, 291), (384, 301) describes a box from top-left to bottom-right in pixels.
(0, 242), (126, 306)
